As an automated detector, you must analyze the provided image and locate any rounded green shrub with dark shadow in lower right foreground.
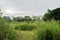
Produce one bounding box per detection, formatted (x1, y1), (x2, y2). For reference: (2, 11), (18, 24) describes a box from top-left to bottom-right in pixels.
(36, 29), (53, 40)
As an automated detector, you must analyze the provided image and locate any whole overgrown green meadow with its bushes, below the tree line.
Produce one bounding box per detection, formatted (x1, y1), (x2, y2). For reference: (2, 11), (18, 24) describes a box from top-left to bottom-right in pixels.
(0, 19), (60, 40)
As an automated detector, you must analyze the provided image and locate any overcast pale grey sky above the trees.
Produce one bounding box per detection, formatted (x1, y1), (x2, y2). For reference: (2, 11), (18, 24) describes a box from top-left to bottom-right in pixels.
(0, 0), (60, 16)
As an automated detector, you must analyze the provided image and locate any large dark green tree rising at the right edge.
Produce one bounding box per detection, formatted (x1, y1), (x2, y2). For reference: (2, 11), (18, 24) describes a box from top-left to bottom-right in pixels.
(43, 8), (60, 20)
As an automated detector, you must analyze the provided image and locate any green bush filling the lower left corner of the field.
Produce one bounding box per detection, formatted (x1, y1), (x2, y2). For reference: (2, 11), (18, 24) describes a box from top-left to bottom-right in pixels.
(0, 19), (16, 40)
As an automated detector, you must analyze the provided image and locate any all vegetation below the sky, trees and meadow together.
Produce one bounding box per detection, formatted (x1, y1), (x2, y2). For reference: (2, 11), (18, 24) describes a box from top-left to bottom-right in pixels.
(0, 8), (60, 40)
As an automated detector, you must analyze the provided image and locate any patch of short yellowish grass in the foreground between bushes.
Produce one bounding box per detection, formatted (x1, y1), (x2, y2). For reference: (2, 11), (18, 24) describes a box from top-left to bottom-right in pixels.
(17, 31), (34, 40)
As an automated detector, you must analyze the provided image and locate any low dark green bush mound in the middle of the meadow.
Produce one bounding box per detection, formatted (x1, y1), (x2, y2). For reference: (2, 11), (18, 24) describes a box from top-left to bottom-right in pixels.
(15, 23), (35, 31)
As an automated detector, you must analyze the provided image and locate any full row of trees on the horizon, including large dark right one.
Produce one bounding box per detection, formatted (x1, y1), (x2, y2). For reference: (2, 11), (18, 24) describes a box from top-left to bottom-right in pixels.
(0, 8), (60, 22)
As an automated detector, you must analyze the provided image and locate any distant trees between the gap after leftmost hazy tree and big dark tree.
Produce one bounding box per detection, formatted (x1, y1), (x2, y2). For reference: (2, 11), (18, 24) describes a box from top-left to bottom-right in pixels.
(13, 16), (40, 22)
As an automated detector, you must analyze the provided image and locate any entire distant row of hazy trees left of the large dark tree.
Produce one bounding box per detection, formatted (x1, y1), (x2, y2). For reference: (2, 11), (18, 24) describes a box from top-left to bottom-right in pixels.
(2, 16), (41, 22)
